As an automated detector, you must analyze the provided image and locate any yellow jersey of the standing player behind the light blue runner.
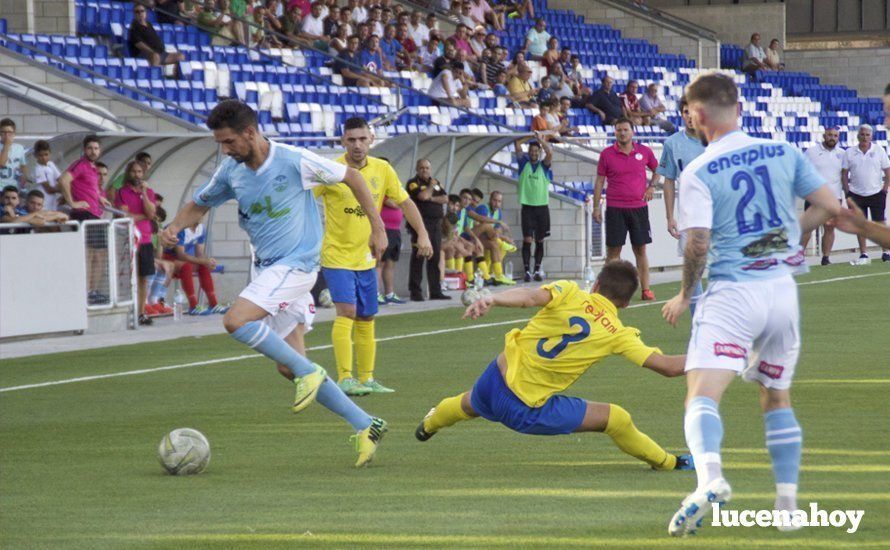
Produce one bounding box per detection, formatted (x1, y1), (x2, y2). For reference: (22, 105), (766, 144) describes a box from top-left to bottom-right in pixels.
(312, 155), (408, 271)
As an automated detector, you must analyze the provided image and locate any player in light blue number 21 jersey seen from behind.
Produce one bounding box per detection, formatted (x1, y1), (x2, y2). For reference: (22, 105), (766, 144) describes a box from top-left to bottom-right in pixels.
(662, 74), (840, 536)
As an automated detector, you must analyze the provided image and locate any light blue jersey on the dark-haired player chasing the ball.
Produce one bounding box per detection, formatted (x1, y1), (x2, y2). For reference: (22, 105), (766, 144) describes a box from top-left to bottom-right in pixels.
(194, 140), (347, 272)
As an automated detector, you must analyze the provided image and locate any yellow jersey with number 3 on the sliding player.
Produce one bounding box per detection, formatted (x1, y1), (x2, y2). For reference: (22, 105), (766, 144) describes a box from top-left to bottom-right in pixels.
(504, 281), (661, 407)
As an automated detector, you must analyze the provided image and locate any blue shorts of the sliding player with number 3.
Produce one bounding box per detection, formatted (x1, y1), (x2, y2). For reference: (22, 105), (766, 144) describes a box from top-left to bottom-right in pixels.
(470, 359), (587, 435)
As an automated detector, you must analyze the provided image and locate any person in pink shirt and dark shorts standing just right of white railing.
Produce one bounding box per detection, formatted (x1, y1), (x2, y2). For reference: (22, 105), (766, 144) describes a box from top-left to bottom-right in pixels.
(114, 160), (157, 325)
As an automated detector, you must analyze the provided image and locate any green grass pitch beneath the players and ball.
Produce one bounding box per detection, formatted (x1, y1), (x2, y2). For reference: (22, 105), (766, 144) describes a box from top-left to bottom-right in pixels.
(0, 264), (890, 549)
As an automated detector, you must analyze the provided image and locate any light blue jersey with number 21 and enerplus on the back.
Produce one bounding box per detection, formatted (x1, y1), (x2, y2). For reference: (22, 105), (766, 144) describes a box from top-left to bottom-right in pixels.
(679, 131), (825, 281)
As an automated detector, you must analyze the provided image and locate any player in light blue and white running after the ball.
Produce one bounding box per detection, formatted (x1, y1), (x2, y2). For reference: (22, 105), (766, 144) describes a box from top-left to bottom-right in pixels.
(160, 100), (387, 467)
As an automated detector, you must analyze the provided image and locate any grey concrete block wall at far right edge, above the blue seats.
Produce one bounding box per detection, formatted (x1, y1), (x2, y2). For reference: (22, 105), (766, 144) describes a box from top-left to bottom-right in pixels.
(785, 48), (890, 97)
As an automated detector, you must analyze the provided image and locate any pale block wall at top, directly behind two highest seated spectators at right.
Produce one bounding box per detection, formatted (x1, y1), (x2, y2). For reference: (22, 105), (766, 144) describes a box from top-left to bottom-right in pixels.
(655, 0), (785, 48)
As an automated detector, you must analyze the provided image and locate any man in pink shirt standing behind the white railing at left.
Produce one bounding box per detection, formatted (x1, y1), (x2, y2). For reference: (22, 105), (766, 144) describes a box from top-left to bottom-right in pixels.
(58, 135), (111, 305)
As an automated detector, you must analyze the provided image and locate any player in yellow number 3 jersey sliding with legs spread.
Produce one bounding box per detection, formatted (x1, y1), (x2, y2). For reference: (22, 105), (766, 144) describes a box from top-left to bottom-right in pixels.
(415, 261), (694, 470)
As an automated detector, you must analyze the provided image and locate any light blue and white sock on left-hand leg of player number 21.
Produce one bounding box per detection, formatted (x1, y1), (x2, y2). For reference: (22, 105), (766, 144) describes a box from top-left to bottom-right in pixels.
(683, 396), (723, 489)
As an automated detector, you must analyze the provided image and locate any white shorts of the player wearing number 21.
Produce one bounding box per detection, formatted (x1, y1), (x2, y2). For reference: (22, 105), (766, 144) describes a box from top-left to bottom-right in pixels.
(686, 275), (800, 390)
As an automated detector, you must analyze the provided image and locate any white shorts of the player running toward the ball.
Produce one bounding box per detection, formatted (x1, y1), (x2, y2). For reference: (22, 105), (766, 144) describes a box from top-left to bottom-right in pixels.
(239, 265), (318, 338)
